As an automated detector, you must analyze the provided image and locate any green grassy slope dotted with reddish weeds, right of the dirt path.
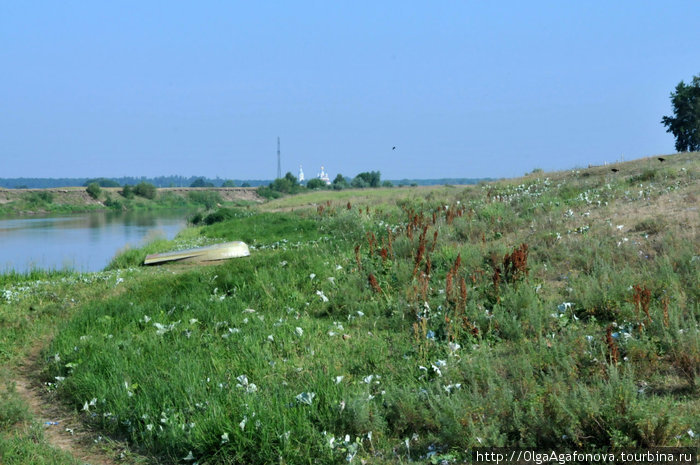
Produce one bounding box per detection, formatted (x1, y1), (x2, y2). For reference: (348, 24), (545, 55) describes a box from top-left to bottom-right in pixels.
(0, 154), (700, 463)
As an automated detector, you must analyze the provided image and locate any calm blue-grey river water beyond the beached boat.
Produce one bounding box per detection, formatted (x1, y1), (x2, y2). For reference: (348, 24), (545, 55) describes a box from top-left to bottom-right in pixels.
(0, 211), (187, 273)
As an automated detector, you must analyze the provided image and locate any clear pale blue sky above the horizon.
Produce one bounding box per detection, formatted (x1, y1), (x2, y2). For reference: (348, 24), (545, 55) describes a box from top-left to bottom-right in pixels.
(0, 0), (700, 179)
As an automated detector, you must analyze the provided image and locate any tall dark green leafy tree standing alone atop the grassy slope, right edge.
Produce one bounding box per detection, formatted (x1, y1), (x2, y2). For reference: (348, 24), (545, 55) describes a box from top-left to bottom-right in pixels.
(661, 75), (700, 152)
